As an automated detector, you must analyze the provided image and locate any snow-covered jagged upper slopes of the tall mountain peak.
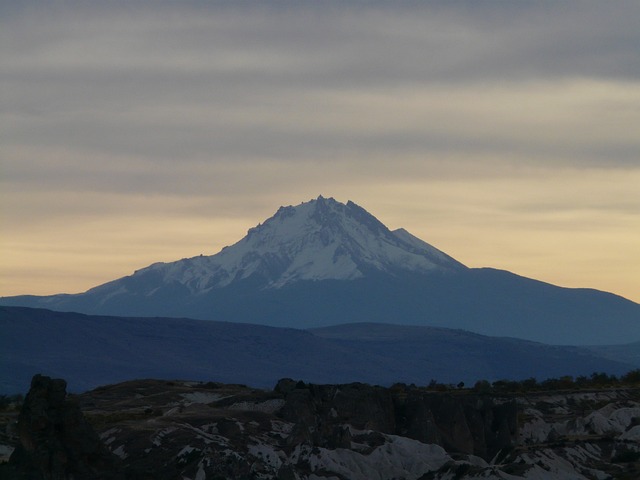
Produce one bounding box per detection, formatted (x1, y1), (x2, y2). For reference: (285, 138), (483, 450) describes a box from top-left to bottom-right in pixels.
(127, 196), (466, 294)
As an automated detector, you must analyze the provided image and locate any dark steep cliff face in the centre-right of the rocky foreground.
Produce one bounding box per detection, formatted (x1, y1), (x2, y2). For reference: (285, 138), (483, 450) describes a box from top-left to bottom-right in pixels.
(276, 379), (518, 460)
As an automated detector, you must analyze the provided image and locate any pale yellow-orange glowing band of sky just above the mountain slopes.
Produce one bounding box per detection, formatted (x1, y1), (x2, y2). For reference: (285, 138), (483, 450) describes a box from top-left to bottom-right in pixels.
(0, 172), (640, 302)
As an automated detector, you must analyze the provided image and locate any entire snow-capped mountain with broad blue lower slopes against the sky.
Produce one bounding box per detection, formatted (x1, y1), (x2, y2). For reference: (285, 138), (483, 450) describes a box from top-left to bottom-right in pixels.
(0, 197), (640, 345)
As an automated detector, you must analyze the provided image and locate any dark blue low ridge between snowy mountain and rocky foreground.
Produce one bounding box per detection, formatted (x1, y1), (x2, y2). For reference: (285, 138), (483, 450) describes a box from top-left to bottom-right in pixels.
(0, 307), (640, 393)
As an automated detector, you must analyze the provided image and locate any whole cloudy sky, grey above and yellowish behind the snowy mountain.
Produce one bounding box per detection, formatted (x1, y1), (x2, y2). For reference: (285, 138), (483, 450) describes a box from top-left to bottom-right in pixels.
(0, 0), (640, 302)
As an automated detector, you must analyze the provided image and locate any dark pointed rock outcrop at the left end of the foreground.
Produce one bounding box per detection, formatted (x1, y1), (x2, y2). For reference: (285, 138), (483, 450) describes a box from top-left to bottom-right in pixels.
(9, 375), (124, 480)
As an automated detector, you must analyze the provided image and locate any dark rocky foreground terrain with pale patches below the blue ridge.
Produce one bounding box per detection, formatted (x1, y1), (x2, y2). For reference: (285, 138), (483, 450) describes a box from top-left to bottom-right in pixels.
(0, 376), (640, 480)
